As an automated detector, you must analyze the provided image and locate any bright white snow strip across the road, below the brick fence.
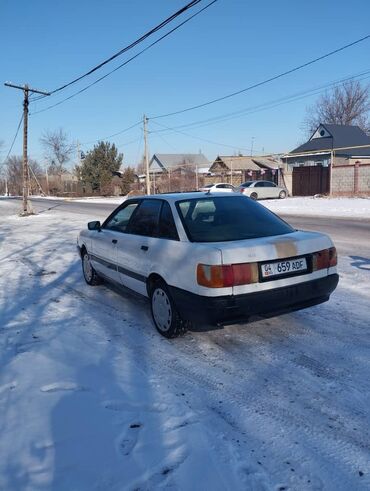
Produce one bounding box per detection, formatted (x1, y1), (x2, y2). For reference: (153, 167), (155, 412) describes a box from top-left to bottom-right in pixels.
(259, 197), (370, 218)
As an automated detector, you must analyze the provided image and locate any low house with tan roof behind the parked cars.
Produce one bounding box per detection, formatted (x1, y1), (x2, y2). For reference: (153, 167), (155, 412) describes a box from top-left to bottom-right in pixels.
(209, 155), (280, 185)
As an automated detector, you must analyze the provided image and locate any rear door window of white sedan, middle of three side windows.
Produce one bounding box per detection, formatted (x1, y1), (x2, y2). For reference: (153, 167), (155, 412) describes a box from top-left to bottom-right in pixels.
(127, 199), (162, 237)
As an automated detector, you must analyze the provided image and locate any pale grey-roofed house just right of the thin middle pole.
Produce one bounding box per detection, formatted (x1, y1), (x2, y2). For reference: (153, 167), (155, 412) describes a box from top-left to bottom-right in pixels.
(149, 153), (209, 174)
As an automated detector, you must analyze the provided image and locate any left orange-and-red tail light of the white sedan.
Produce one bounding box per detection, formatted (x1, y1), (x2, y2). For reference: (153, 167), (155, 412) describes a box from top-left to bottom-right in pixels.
(197, 263), (258, 288)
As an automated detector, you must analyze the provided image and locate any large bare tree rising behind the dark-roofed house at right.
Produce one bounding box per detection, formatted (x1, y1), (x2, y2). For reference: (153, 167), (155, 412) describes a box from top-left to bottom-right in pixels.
(304, 80), (370, 135)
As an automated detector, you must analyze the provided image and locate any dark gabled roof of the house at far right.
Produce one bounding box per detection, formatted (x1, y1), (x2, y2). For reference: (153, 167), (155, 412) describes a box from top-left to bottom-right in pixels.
(290, 124), (370, 155)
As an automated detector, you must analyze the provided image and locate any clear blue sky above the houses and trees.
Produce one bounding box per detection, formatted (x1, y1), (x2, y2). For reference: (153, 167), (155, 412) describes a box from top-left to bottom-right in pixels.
(0, 0), (370, 165)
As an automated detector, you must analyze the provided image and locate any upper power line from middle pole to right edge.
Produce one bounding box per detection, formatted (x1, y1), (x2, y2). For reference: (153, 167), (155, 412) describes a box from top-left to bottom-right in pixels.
(149, 34), (370, 120)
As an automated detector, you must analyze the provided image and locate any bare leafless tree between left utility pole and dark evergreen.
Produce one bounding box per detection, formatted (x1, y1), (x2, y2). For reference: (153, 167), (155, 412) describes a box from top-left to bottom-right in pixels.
(40, 128), (75, 175)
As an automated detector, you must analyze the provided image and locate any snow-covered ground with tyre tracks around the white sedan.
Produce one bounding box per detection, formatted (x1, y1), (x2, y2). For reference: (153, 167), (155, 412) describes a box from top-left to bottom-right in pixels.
(0, 200), (370, 491)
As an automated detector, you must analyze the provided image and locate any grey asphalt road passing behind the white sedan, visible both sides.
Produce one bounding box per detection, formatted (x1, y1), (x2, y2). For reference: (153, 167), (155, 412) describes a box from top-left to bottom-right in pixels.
(5, 198), (370, 257)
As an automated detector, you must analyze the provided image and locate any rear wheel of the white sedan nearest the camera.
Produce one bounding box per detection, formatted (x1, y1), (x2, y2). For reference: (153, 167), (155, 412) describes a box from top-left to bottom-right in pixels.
(150, 281), (186, 338)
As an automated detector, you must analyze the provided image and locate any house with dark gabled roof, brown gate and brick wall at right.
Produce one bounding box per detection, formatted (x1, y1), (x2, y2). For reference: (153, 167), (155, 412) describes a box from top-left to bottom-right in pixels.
(282, 124), (370, 196)
